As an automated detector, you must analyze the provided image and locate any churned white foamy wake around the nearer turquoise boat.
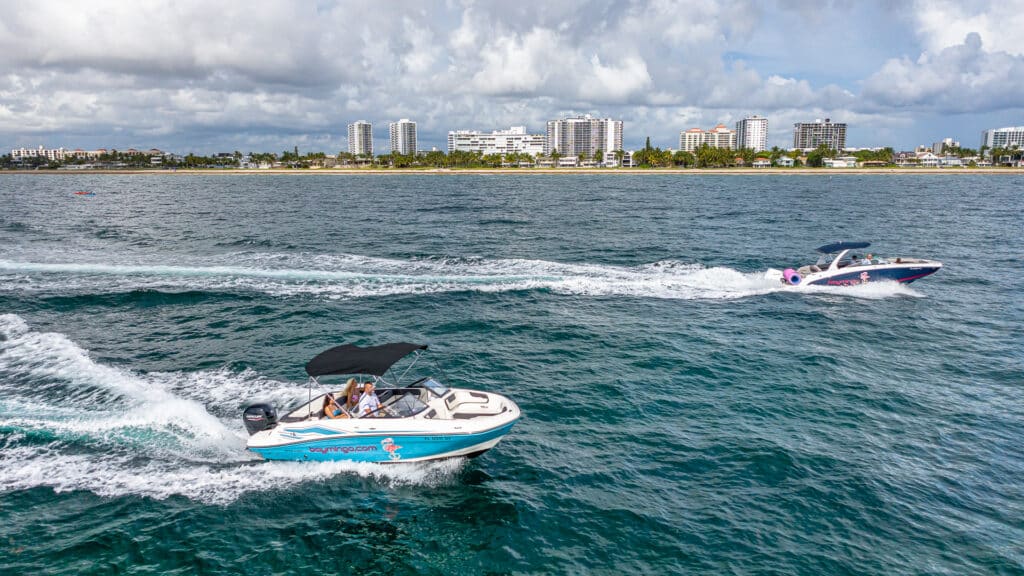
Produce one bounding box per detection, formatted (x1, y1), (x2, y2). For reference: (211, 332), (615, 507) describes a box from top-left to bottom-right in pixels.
(0, 315), (464, 504)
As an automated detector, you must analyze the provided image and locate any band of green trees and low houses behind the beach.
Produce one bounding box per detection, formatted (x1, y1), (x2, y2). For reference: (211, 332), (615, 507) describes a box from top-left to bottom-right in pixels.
(0, 138), (1024, 172)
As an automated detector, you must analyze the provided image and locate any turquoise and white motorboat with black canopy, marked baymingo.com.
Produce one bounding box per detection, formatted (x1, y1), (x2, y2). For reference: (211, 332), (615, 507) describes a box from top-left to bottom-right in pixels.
(243, 342), (520, 462)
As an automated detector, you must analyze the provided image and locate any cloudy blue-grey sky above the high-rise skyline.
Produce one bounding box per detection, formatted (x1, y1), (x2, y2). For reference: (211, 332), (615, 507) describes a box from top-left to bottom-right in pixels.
(0, 0), (1024, 154)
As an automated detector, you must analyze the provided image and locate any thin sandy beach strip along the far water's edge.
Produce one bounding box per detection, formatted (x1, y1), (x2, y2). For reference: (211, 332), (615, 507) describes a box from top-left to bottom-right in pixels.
(0, 168), (1024, 176)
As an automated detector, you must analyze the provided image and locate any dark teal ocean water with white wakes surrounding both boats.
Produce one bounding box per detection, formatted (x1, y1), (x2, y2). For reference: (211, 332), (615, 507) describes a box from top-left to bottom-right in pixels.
(0, 174), (1024, 575)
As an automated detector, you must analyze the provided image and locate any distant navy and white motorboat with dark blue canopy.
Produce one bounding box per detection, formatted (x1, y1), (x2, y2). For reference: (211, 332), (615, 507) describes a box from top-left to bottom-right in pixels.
(765, 242), (942, 286)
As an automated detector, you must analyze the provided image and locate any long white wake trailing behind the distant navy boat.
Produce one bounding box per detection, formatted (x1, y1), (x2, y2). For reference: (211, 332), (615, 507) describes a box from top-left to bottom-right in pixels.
(0, 252), (915, 299)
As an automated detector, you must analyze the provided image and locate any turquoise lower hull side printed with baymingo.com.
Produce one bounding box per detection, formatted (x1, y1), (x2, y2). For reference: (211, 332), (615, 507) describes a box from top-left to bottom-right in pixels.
(250, 421), (515, 462)
